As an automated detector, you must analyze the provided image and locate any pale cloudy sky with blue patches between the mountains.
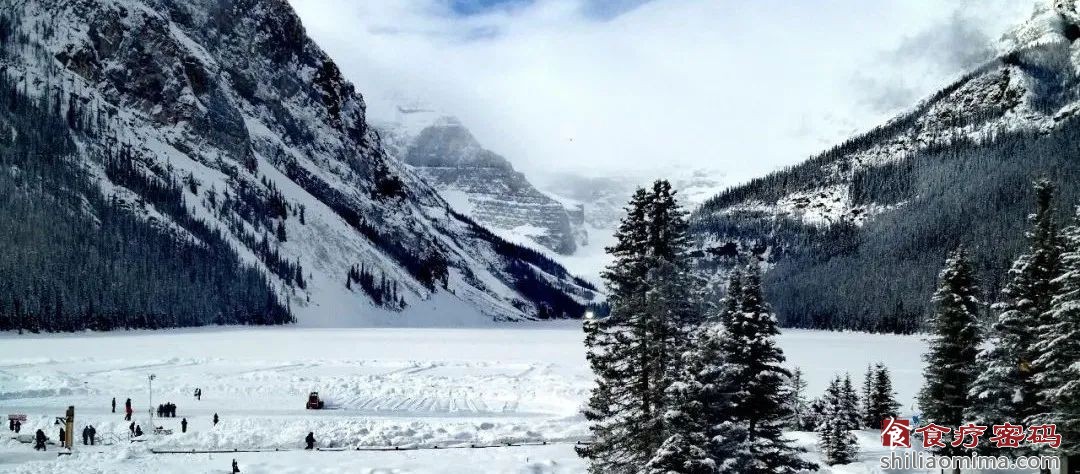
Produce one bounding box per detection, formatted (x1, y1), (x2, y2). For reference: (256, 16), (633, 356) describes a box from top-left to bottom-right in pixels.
(289, 0), (1034, 182)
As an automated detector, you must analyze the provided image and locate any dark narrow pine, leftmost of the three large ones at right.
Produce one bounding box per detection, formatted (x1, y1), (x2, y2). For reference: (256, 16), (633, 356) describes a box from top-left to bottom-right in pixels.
(919, 247), (980, 453)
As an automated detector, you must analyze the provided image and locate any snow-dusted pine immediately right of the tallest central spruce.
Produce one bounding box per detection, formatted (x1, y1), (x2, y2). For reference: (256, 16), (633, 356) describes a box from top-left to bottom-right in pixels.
(721, 262), (812, 473)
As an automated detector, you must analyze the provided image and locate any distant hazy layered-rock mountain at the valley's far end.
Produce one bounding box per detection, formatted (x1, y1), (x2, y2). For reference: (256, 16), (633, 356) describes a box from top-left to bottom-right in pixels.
(373, 106), (589, 255)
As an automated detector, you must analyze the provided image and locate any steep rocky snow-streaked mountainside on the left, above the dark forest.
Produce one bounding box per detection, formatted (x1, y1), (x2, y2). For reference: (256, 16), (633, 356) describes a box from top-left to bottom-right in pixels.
(0, 0), (593, 325)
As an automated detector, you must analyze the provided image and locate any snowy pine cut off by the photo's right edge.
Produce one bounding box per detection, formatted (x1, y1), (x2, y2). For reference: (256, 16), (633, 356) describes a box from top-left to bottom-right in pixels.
(1032, 208), (1080, 455)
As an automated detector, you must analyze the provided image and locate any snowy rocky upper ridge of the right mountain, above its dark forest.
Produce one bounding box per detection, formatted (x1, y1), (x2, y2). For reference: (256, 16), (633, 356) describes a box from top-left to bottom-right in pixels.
(699, 0), (1080, 231)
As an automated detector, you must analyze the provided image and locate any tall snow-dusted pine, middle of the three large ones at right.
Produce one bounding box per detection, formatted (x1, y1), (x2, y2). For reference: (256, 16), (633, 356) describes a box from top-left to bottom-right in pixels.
(968, 180), (1061, 438)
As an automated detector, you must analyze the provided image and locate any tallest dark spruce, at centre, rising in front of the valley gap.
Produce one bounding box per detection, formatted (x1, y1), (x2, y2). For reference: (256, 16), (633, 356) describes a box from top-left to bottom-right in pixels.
(578, 180), (702, 473)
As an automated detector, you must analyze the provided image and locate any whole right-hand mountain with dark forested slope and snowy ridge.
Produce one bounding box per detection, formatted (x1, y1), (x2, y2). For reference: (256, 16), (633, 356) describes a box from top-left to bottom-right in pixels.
(693, 0), (1080, 330)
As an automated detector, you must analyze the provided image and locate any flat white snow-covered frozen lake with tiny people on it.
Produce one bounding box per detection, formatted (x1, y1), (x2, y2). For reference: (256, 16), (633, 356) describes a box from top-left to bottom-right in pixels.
(0, 322), (972, 473)
